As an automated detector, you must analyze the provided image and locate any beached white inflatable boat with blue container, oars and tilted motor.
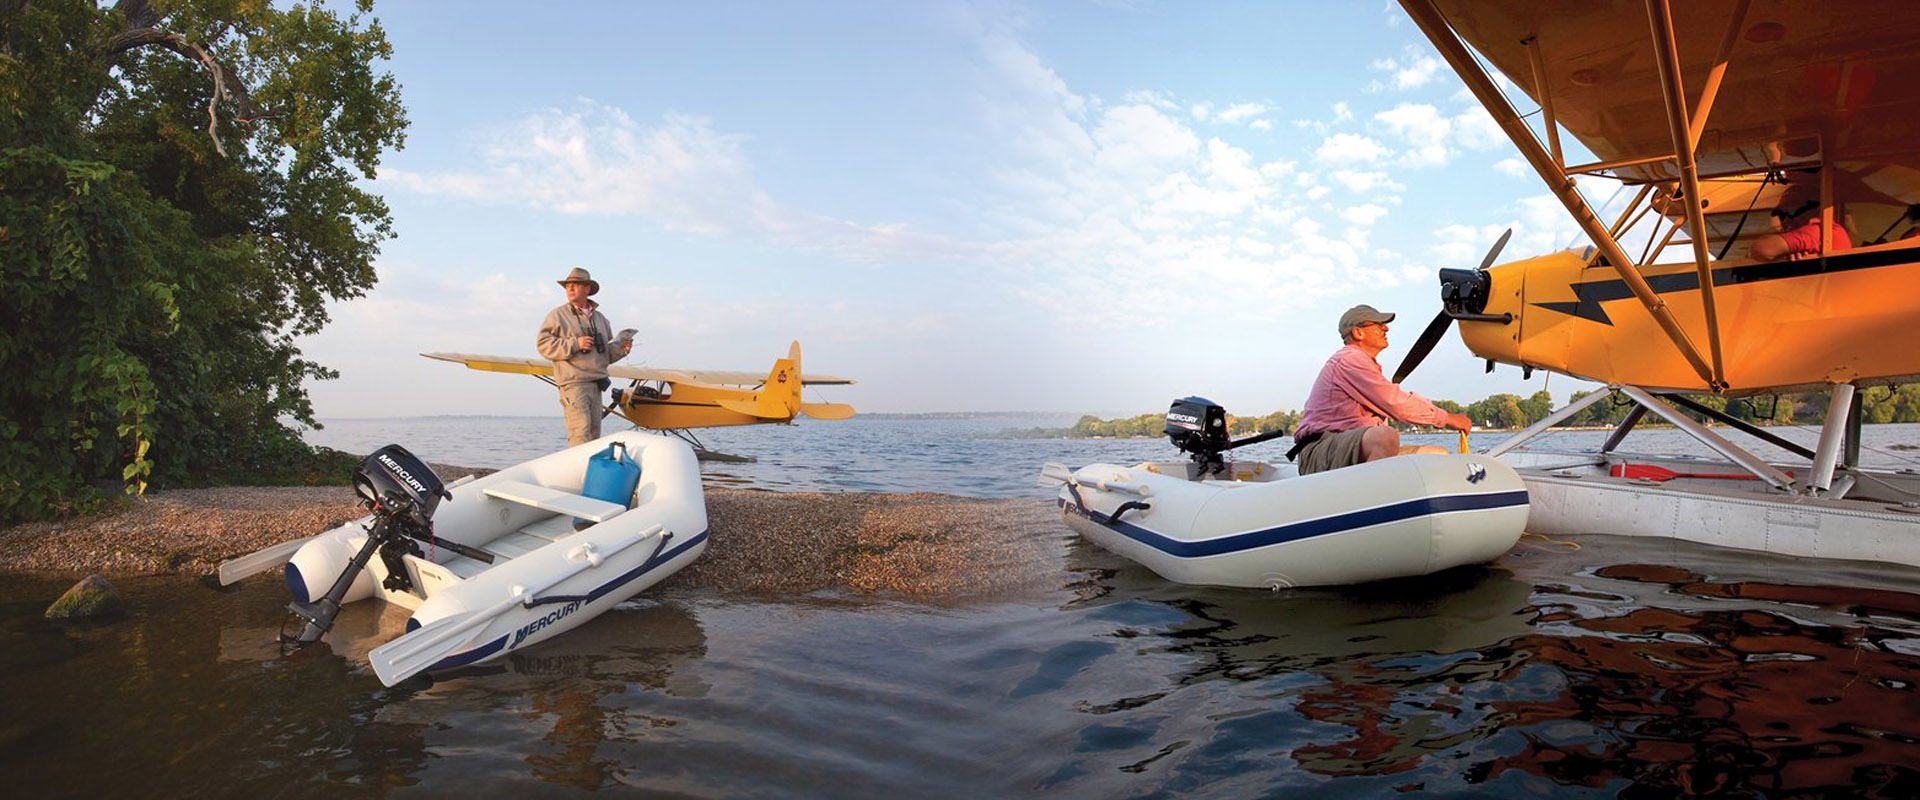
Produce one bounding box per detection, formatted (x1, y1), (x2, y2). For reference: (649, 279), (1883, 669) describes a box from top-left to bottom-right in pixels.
(221, 432), (707, 685)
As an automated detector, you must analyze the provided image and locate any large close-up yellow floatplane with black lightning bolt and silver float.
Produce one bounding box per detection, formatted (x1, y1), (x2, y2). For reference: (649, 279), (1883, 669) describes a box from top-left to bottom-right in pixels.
(1396, 0), (1920, 566)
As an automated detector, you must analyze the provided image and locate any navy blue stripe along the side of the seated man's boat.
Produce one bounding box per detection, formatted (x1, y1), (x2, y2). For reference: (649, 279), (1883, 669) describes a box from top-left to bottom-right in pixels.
(1058, 489), (1526, 558)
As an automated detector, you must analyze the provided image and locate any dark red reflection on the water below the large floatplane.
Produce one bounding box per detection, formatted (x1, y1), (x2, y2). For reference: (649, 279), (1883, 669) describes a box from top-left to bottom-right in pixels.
(1469, 564), (1920, 796)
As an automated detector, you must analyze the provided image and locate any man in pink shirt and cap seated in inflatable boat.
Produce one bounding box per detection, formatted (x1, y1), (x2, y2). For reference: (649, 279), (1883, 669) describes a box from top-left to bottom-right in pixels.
(1286, 305), (1473, 476)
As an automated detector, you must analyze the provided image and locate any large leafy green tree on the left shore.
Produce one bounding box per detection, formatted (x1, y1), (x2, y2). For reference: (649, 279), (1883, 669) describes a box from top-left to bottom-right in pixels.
(0, 0), (405, 520)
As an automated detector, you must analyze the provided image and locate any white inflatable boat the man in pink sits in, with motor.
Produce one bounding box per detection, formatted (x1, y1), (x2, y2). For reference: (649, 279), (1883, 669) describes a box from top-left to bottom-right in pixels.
(1041, 399), (1528, 589)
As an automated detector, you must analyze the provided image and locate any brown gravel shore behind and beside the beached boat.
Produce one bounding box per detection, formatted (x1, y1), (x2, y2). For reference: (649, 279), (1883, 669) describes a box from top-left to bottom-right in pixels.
(0, 464), (1069, 599)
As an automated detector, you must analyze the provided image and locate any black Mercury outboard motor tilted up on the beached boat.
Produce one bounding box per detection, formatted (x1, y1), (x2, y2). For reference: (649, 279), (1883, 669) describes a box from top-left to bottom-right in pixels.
(284, 445), (453, 647)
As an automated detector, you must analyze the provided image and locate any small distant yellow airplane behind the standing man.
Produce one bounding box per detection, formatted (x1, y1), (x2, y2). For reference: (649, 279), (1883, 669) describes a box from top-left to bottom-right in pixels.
(435, 341), (854, 445)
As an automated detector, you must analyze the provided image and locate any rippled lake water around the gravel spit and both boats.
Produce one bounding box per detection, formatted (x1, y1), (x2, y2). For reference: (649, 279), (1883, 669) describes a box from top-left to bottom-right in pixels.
(0, 418), (1920, 798)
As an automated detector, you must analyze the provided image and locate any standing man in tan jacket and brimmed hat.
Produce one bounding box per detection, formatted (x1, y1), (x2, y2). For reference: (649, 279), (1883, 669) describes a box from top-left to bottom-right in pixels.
(534, 267), (634, 447)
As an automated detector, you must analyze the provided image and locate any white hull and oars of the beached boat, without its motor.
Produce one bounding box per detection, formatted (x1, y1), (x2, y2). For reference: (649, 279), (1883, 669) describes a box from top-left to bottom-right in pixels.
(286, 432), (707, 671)
